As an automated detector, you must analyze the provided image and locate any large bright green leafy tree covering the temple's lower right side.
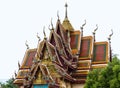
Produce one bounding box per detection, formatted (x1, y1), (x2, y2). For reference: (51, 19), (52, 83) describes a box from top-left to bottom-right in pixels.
(84, 56), (120, 88)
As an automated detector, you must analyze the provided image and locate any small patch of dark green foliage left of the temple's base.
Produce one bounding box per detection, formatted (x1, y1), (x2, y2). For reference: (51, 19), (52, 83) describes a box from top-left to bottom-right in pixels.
(0, 78), (18, 88)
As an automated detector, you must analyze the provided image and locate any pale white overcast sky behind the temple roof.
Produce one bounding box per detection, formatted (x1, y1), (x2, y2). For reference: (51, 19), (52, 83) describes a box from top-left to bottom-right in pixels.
(0, 0), (120, 79)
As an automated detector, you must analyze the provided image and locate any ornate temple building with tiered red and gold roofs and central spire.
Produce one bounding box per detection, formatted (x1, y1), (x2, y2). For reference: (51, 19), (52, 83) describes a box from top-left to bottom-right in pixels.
(14, 4), (113, 88)
